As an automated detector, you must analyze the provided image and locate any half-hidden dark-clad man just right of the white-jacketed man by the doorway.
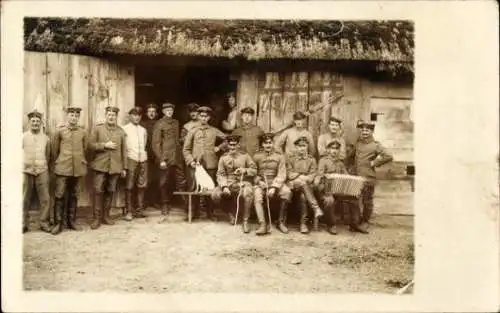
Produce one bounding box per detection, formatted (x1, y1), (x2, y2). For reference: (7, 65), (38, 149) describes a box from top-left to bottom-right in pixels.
(141, 103), (159, 206)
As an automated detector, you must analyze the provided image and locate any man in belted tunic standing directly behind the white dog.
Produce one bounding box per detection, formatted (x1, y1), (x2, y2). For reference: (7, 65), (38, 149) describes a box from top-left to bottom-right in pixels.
(183, 106), (226, 219)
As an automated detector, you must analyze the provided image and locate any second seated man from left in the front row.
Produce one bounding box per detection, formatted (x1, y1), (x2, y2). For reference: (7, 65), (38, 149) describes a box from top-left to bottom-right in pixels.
(254, 133), (292, 235)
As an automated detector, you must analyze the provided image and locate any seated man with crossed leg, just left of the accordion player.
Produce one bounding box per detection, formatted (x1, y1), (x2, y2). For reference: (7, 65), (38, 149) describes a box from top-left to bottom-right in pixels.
(286, 137), (323, 234)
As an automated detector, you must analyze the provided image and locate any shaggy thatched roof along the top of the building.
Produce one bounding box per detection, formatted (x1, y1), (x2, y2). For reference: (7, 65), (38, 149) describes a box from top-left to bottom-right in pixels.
(24, 18), (414, 71)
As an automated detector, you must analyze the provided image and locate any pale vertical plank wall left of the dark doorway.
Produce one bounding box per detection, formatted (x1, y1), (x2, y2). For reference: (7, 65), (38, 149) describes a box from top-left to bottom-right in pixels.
(23, 52), (135, 207)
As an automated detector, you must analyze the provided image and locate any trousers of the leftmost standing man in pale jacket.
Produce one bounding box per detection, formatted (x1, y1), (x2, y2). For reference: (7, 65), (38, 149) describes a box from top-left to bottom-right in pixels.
(23, 171), (50, 227)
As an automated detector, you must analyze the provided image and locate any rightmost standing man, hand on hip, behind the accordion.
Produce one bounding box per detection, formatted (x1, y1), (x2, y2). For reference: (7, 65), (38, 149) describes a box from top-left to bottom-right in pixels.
(354, 120), (393, 224)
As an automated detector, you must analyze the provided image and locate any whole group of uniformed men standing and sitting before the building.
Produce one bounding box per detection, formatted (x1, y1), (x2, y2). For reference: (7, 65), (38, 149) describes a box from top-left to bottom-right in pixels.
(23, 94), (392, 235)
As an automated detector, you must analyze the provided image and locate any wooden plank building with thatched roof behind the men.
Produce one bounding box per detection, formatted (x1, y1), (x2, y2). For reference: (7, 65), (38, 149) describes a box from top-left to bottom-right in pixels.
(24, 18), (414, 206)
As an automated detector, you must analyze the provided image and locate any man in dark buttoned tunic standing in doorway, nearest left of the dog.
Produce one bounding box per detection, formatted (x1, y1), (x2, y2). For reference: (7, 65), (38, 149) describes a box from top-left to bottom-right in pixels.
(153, 102), (186, 215)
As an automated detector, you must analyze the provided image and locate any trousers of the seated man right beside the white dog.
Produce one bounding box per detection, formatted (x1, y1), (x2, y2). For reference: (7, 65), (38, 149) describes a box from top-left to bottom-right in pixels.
(212, 182), (254, 221)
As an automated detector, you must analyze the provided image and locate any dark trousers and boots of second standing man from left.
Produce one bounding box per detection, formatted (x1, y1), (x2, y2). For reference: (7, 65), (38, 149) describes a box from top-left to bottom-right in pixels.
(54, 175), (82, 224)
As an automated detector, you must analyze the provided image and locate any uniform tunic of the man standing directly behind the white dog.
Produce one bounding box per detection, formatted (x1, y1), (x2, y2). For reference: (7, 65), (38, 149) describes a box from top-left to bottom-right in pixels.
(183, 125), (226, 169)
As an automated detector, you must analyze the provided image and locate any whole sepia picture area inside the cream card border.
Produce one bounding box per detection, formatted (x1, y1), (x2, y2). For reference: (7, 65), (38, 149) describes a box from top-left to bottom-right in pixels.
(20, 16), (416, 294)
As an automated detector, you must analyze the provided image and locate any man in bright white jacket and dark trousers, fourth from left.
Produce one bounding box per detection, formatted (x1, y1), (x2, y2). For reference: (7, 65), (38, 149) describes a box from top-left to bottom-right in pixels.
(123, 107), (148, 221)
